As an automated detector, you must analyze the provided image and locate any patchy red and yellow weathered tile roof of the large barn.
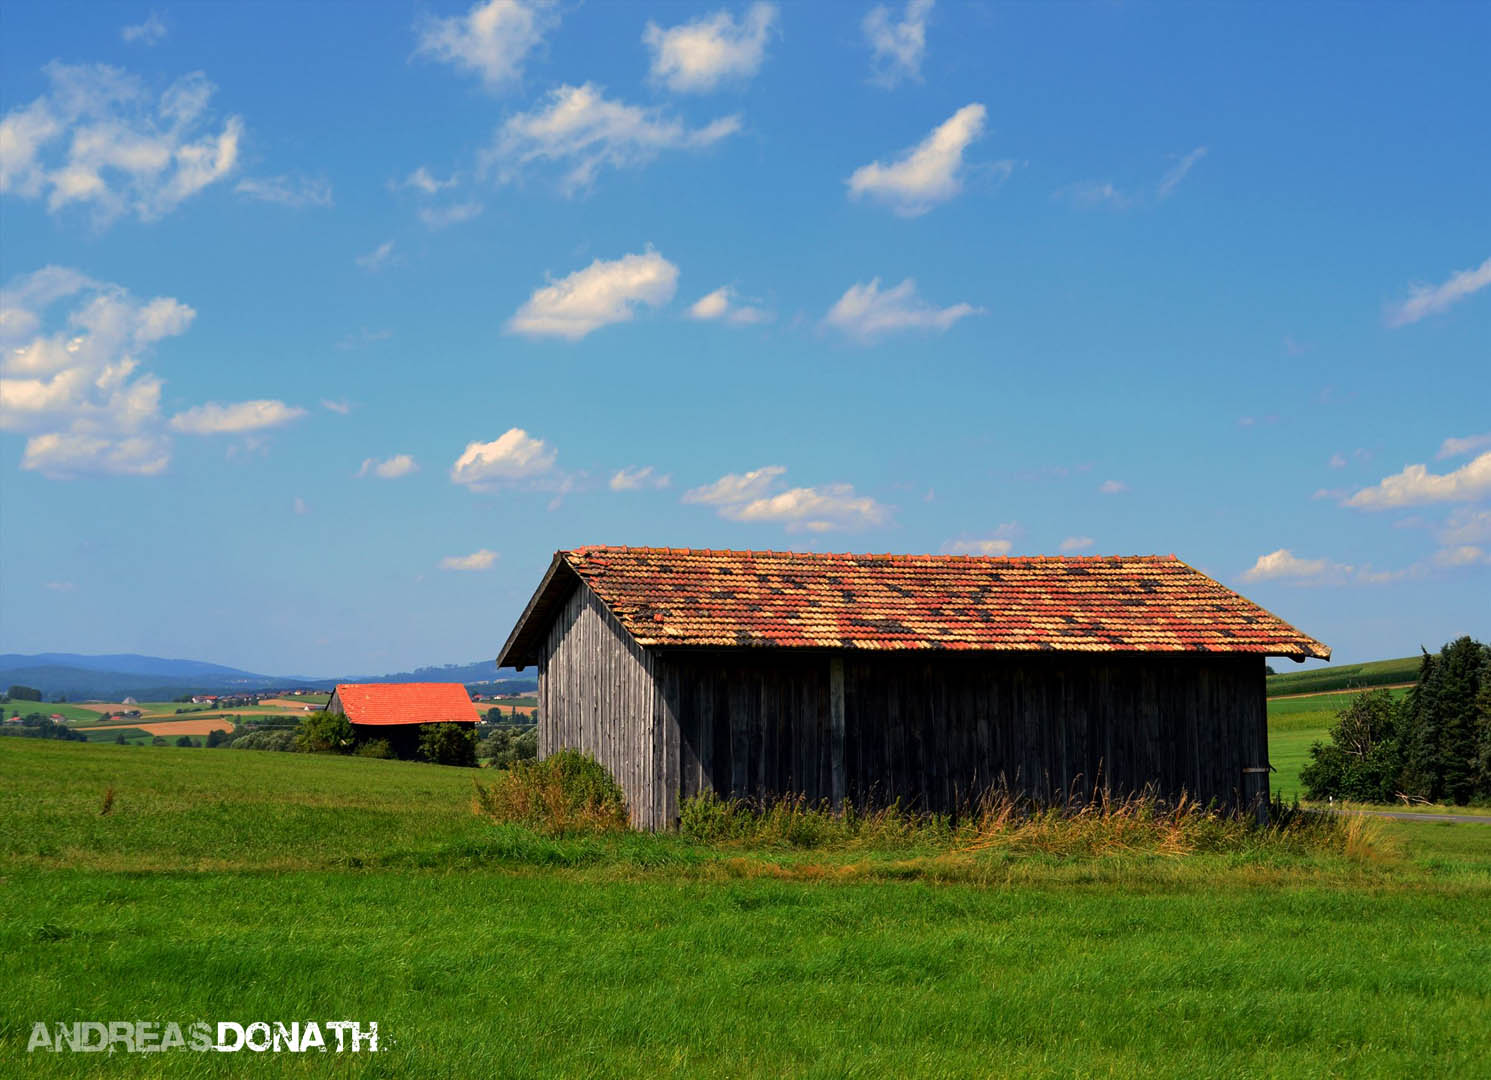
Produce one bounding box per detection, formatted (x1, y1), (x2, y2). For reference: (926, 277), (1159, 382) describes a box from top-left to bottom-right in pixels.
(504, 547), (1330, 664)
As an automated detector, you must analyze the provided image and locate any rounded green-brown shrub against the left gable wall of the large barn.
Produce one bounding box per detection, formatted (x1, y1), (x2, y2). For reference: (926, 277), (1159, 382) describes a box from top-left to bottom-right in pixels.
(476, 750), (628, 834)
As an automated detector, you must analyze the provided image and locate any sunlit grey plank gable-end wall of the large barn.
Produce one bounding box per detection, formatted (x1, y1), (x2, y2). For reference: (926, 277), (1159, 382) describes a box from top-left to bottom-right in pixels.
(538, 585), (664, 829)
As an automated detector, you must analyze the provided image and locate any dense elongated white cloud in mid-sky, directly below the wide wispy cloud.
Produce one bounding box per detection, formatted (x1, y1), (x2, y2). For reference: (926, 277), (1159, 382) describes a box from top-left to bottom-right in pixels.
(507, 249), (678, 342)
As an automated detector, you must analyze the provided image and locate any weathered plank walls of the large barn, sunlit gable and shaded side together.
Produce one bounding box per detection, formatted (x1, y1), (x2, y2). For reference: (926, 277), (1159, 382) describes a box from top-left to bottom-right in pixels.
(538, 585), (1267, 828)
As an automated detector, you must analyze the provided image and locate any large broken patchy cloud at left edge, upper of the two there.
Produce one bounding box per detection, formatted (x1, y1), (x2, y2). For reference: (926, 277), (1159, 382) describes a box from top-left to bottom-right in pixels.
(0, 61), (243, 225)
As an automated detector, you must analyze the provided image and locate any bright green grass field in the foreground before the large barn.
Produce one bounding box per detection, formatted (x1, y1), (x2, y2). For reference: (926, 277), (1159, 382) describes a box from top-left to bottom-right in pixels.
(0, 740), (1491, 1077)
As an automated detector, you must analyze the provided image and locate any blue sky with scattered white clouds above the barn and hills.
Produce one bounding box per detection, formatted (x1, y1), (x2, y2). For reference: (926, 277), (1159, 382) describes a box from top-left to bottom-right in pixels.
(0, 0), (1491, 674)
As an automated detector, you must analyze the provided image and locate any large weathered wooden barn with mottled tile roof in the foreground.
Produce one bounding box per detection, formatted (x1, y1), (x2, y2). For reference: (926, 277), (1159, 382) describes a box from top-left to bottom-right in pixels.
(497, 547), (1330, 828)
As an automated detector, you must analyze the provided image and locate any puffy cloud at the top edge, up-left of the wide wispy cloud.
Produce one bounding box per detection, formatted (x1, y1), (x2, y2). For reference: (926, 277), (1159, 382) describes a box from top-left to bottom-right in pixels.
(416, 0), (559, 90)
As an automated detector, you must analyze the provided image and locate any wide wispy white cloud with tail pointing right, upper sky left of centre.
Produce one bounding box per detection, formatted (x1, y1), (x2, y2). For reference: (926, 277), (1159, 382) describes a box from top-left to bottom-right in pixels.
(483, 82), (741, 194)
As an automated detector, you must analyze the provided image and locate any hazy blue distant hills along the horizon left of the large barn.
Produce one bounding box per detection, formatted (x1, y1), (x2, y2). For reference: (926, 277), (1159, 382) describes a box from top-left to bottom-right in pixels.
(0, 652), (537, 701)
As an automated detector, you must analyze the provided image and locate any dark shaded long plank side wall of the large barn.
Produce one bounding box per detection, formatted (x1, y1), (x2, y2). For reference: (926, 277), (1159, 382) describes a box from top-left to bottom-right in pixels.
(656, 650), (1267, 820)
